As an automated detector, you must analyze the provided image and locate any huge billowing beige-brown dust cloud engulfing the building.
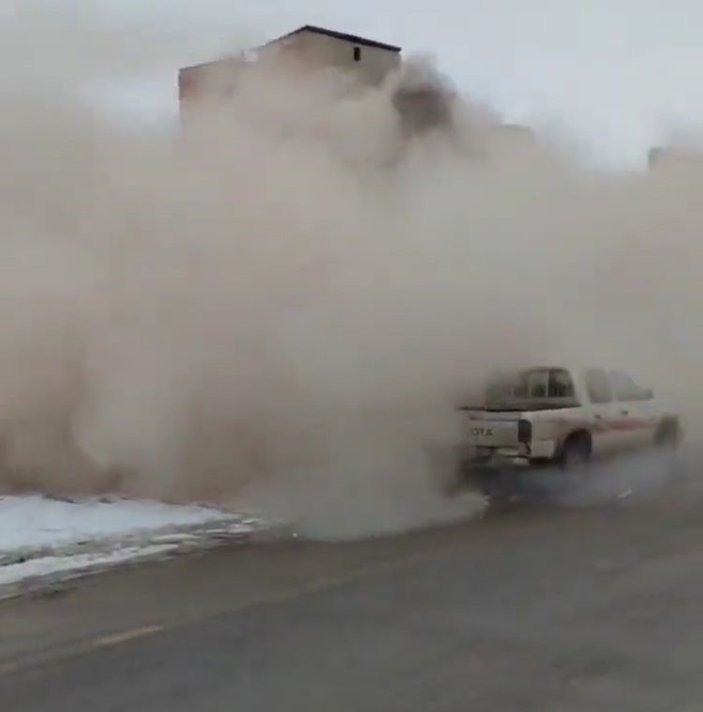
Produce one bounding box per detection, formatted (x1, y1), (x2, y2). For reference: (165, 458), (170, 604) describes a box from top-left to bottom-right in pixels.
(0, 5), (703, 537)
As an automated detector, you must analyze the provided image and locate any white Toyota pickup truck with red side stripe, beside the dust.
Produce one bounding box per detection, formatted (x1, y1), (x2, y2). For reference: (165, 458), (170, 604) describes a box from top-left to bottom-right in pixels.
(459, 367), (682, 494)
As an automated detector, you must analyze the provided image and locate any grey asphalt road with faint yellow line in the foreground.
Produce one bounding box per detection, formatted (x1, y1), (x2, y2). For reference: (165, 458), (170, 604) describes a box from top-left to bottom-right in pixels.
(0, 482), (703, 712)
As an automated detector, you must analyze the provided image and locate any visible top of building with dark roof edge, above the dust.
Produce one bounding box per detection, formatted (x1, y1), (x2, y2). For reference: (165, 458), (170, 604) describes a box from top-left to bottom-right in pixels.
(178, 25), (401, 112)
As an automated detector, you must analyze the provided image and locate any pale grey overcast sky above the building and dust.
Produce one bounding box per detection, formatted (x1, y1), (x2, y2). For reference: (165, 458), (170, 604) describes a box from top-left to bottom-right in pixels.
(97, 0), (703, 165)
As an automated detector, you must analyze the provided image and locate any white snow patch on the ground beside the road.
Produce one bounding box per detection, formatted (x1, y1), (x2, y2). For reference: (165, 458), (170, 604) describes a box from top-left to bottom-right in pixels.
(0, 495), (261, 597)
